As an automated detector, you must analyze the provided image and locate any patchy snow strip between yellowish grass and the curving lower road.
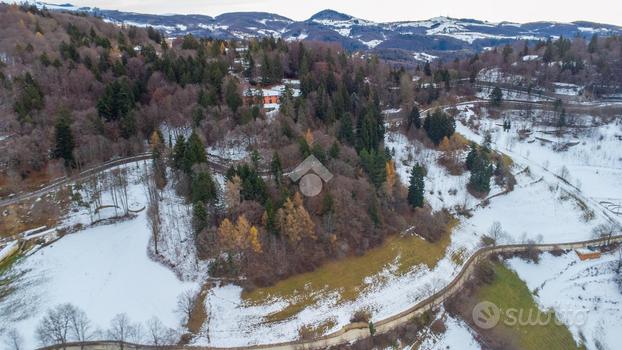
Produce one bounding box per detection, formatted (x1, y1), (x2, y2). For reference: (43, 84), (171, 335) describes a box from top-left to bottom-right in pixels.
(193, 252), (466, 347)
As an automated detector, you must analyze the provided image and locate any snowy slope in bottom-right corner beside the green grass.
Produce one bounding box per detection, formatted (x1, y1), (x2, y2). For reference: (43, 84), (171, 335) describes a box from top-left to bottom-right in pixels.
(508, 251), (622, 349)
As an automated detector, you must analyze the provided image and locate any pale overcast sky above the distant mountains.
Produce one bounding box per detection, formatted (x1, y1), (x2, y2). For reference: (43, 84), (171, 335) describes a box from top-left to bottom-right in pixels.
(63, 0), (622, 25)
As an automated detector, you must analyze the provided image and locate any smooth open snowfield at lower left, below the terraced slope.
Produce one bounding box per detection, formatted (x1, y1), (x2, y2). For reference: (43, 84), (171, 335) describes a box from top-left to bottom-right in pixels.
(0, 212), (197, 349)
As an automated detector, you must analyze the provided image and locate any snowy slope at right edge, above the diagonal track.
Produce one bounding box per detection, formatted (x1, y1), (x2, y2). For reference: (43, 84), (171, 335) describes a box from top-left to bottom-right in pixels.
(457, 106), (622, 219)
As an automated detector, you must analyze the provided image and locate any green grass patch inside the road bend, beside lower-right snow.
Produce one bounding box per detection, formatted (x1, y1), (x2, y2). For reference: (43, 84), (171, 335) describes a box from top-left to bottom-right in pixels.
(476, 264), (581, 350)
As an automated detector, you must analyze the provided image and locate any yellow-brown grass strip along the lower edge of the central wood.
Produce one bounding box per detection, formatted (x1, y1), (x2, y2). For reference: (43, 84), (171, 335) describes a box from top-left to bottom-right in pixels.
(242, 229), (451, 322)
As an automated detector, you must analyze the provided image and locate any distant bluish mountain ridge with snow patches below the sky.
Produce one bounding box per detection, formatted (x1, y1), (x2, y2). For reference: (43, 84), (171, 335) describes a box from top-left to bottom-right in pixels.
(15, 1), (622, 59)
